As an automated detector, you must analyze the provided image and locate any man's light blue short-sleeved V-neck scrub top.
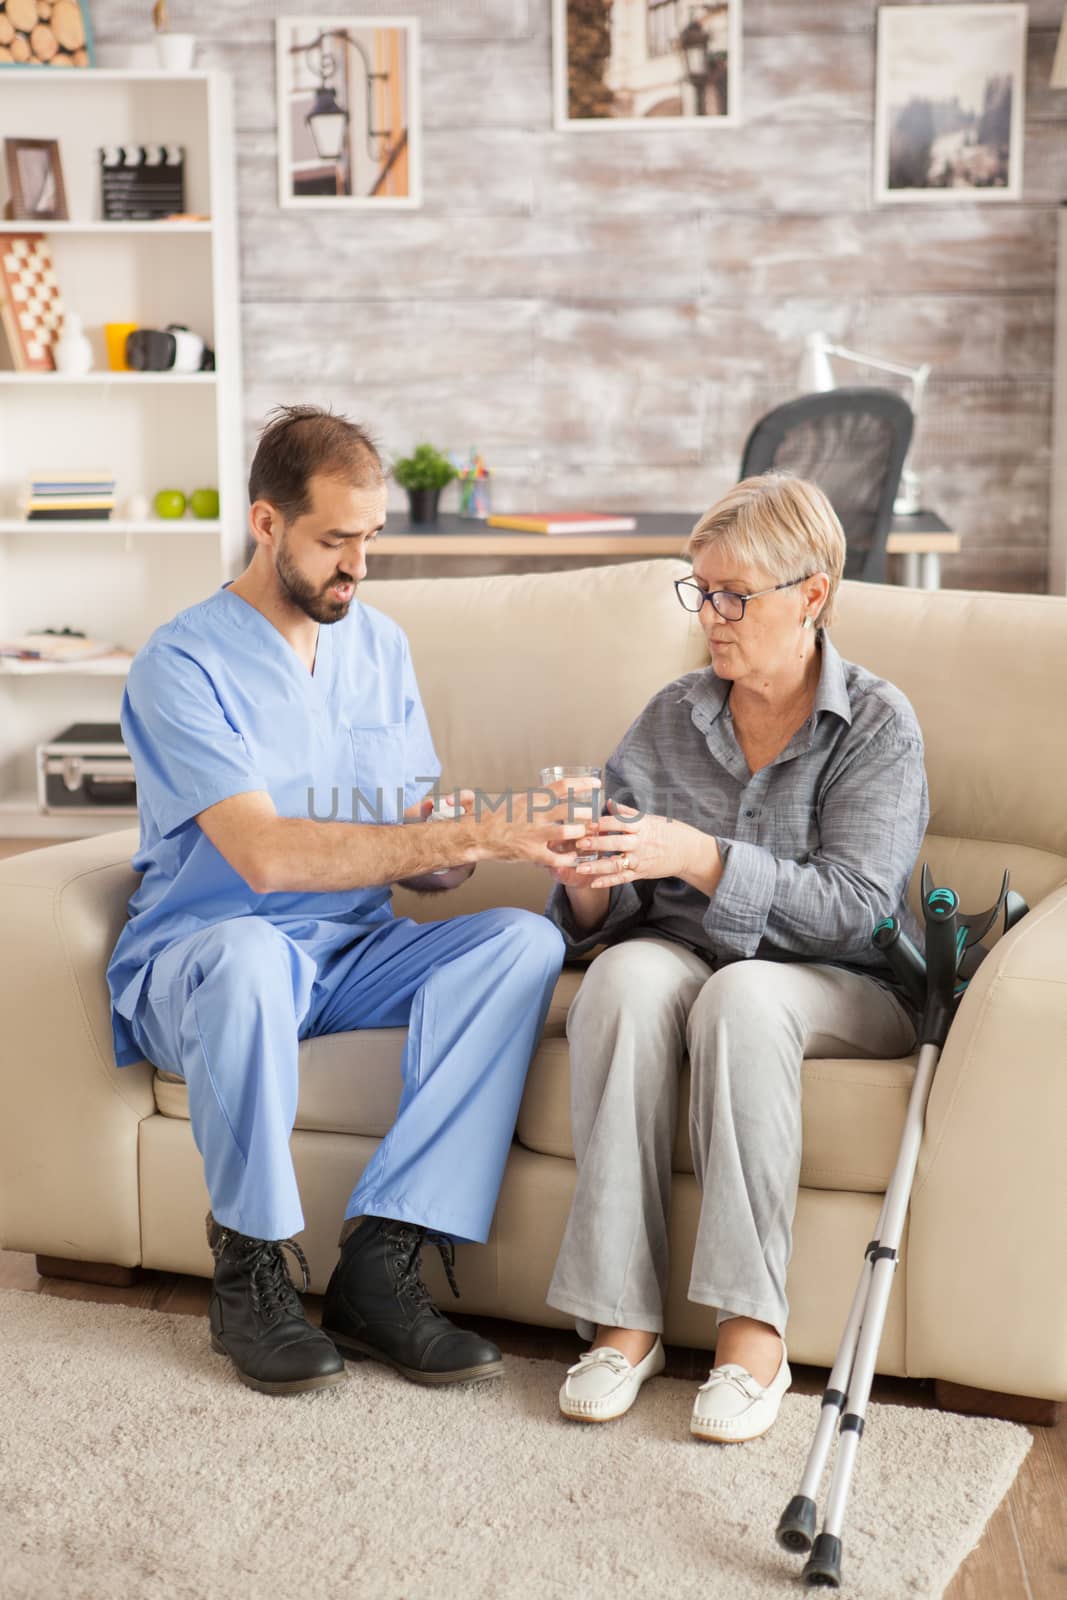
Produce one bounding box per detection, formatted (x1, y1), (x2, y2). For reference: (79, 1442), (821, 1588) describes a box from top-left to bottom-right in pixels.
(107, 586), (440, 1067)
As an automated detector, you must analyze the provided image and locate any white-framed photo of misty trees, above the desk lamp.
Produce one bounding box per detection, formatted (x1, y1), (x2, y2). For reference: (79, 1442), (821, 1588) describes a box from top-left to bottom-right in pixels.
(873, 5), (1027, 203)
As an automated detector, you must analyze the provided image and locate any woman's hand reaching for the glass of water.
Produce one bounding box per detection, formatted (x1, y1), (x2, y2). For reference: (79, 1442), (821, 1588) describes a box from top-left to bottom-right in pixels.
(557, 800), (723, 898)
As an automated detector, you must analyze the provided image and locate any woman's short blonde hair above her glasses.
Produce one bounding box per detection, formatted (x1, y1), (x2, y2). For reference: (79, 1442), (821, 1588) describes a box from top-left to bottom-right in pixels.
(686, 472), (845, 627)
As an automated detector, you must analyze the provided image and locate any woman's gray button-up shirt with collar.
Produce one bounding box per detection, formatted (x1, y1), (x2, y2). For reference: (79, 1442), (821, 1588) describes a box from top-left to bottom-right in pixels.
(547, 632), (929, 1010)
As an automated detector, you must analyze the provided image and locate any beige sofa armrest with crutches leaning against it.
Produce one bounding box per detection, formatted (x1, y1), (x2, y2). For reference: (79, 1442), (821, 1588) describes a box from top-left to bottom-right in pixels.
(907, 883), (1067, 1400)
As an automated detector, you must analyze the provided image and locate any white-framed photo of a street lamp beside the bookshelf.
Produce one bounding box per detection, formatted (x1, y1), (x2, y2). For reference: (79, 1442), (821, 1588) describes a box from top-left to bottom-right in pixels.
(275, 16), (422, 210)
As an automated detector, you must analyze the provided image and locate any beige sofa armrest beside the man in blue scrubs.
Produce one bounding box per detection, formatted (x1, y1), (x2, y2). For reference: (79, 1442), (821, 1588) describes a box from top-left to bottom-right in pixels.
(0, 830), (155, 1266)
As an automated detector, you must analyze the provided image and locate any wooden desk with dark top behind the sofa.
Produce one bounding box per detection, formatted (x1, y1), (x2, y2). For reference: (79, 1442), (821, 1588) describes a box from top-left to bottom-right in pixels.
(371, 512), (960, 589)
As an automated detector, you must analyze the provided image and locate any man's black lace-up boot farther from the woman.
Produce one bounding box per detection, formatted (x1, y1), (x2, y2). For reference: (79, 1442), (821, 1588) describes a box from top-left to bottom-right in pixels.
(208, 1211), (346, 1395)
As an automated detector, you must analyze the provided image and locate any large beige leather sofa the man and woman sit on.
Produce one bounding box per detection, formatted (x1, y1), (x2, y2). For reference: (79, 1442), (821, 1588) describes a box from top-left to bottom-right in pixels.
(0, 562), (1067, 1400)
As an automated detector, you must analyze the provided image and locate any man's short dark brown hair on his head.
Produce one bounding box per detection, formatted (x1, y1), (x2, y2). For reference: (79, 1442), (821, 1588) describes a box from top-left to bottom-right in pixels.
(248, 405), (386, 522)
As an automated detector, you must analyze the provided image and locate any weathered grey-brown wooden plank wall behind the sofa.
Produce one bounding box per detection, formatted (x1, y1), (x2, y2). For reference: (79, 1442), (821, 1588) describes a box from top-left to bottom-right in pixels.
(93, 0), (1067, 590)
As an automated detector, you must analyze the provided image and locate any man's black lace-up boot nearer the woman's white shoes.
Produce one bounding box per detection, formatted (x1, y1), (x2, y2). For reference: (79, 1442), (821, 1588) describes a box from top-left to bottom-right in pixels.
(322, 1216), (504, 1384)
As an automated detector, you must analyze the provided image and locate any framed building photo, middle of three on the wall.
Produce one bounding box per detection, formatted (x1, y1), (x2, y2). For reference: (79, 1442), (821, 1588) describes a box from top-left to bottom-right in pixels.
(552, 0), (741, 131)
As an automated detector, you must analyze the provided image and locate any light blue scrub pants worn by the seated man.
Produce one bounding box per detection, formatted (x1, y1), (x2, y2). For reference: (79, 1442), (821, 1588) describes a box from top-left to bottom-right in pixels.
(131, 909), (563, 1242)
